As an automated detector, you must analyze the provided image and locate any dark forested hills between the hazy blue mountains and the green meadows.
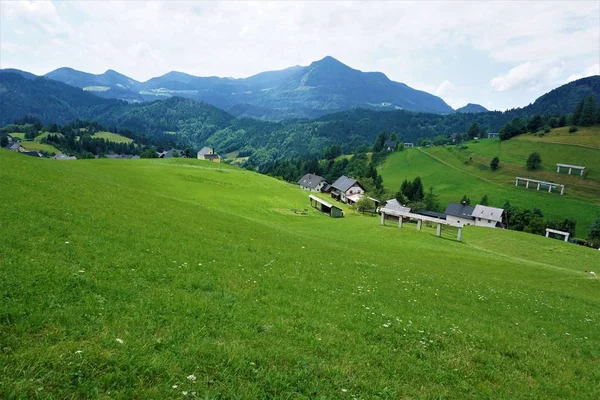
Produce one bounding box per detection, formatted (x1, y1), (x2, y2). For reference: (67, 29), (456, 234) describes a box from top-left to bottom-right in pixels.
(0, 72), (600, 170)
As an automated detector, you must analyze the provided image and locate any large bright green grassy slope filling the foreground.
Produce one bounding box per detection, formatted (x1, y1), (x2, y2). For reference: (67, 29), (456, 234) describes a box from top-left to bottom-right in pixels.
(0, 151), (600, 399)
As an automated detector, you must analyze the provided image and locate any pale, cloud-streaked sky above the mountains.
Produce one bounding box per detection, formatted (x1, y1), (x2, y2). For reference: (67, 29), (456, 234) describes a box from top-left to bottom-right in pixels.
(0, 0), (600, 110)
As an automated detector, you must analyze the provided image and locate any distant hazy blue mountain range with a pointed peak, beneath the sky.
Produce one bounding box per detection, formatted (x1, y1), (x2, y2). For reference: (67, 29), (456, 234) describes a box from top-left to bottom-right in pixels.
(45, 56), (454, 120)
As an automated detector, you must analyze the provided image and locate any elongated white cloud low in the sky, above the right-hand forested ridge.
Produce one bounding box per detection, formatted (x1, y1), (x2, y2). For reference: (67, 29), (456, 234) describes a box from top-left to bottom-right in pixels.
(490, 60), (565, 92)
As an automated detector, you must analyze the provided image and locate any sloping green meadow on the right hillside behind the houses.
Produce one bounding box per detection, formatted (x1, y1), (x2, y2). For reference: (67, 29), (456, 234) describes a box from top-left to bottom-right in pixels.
(380, 130), (600, 236)
